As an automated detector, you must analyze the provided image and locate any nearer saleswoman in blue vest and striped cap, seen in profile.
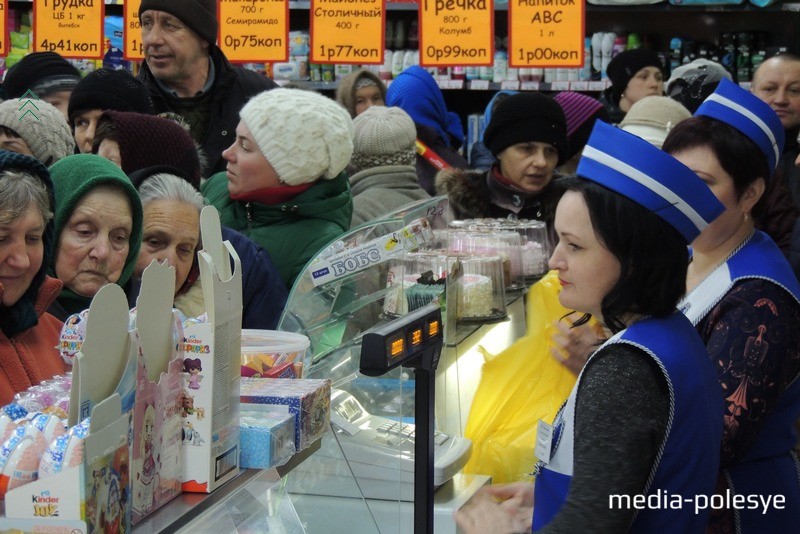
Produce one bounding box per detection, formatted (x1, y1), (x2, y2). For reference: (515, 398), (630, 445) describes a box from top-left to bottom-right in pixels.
(456, 122), (723, 533)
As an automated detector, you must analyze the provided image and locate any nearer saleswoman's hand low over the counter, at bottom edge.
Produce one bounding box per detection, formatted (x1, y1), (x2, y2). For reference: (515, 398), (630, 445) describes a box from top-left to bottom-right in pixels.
(454, 482), (533, 534)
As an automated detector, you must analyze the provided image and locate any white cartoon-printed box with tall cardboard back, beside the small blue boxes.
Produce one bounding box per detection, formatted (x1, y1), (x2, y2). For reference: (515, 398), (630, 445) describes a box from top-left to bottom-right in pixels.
(180, 206), (242, 493)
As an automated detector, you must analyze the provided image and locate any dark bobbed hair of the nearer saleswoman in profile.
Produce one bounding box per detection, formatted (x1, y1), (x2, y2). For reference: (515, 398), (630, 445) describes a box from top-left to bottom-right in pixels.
(560, 176), (689, 332)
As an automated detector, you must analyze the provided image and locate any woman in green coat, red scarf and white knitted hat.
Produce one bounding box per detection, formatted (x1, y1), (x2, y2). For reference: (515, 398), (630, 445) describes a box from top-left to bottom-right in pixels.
(202, 89), (353, 289)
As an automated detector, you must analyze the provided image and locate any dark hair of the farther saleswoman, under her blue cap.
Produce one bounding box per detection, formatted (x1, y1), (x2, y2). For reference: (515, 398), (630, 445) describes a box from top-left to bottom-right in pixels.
(662, 115), (772, 203)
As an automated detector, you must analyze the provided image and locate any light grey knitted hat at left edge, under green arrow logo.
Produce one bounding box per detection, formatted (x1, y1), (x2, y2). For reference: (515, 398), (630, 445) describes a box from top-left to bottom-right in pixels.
(0, 98), (75, 167)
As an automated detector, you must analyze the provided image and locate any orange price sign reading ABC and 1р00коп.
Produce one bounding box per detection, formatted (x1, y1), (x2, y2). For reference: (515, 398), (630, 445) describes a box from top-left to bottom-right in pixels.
(508, 0), (586, 68)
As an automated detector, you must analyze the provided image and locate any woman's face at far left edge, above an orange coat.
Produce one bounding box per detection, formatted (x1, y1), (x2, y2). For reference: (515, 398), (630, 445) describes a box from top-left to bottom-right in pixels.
(0, 204), (45, 306)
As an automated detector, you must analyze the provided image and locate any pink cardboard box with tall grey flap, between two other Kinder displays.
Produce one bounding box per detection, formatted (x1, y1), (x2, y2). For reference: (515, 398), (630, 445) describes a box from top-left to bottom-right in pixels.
(130, 260), (183, 524)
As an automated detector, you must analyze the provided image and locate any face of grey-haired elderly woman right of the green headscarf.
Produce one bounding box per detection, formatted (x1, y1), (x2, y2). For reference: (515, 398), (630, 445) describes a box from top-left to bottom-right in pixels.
(133, 199), (200, 291)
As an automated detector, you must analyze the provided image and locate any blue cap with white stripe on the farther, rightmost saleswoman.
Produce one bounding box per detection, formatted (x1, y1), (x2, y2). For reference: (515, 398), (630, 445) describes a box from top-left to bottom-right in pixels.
(695, 80), (785, 174)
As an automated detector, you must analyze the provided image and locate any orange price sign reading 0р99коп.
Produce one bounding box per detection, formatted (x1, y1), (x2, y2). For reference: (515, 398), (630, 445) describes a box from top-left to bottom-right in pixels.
(419, 0), (494, 67)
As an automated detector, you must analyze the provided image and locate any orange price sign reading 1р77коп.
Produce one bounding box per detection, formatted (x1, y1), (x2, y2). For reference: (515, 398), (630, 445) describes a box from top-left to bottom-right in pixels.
(311, 0), (386, 65)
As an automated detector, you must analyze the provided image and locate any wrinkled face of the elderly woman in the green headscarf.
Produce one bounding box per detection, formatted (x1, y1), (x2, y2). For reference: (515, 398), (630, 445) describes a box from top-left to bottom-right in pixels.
(56, 187), (133, 297)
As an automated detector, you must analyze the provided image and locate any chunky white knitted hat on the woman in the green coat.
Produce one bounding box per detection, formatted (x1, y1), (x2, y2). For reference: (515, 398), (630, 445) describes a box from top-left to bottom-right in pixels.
(239, 89), (353, 185)
